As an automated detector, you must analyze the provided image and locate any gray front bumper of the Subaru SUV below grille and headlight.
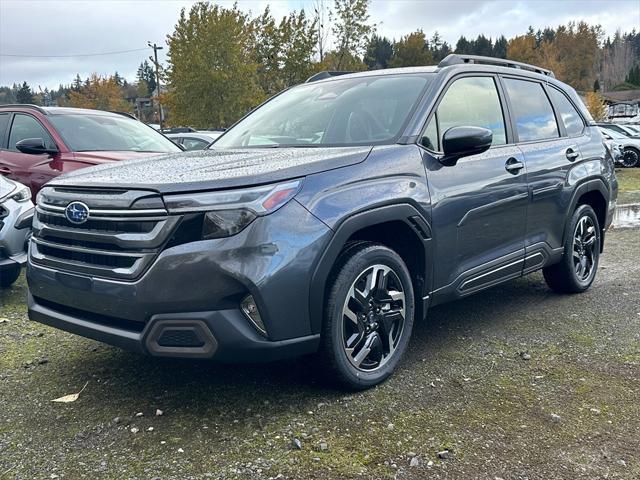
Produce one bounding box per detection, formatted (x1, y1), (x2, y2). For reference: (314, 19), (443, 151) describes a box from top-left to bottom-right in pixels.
(27, 201), (330, 361)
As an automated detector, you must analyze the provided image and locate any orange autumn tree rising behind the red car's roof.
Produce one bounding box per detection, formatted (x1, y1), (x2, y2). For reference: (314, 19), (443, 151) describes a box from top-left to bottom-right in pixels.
(67, 73), (131, 112)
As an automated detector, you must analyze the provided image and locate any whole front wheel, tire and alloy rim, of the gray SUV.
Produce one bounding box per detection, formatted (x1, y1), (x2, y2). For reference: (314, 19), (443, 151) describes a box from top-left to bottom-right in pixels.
(319, 242), (415, 390)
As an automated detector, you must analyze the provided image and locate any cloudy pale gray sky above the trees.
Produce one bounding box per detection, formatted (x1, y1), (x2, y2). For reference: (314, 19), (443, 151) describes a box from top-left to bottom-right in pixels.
(0, 0), (640, 89)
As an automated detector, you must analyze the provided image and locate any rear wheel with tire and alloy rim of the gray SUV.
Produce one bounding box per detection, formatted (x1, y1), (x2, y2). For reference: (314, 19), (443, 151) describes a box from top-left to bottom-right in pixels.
(542, 205), (601, 293)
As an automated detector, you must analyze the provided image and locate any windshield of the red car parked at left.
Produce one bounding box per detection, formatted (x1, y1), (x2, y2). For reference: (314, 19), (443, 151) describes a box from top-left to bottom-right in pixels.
(48, 114), (181, 152)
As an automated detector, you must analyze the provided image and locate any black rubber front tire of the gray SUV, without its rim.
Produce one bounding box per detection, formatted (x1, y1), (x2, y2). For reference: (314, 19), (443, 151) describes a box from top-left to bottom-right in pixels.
(325, 244), (415, 389)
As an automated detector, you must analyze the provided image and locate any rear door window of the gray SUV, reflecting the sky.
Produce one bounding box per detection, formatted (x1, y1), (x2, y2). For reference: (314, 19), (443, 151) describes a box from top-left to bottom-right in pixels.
(504, 78), (560, 142)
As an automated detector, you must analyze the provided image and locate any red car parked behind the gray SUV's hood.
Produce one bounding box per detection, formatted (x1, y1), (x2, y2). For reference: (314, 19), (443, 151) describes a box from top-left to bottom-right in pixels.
(0, 105), (181, 198)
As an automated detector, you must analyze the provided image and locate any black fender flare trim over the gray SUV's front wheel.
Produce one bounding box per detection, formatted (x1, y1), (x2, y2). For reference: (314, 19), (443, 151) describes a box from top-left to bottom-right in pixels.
(309, 203), (433, 334)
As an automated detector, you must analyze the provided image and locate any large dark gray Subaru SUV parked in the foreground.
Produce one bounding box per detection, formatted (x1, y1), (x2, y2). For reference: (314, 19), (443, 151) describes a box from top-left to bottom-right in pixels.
(28, 55), (617, 388)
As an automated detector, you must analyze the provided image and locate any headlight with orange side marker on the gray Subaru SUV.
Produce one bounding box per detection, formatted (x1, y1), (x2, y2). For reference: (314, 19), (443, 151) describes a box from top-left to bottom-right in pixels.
(164, 180), (302, 240)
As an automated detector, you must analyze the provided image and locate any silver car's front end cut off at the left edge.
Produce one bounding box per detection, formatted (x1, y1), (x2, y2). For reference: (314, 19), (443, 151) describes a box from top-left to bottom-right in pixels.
(0, 176), (34, 288)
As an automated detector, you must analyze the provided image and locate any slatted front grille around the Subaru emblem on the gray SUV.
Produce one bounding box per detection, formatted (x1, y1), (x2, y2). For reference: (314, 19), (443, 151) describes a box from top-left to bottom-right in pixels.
(30, 187), (181, 281)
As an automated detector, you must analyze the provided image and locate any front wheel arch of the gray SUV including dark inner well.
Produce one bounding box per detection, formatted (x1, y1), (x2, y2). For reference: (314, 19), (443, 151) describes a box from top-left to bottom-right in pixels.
(309, 204), (433, 333)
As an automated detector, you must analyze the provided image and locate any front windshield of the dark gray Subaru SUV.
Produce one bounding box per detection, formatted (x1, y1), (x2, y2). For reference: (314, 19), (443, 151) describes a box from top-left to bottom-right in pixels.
(211, 74), (432, 148)
